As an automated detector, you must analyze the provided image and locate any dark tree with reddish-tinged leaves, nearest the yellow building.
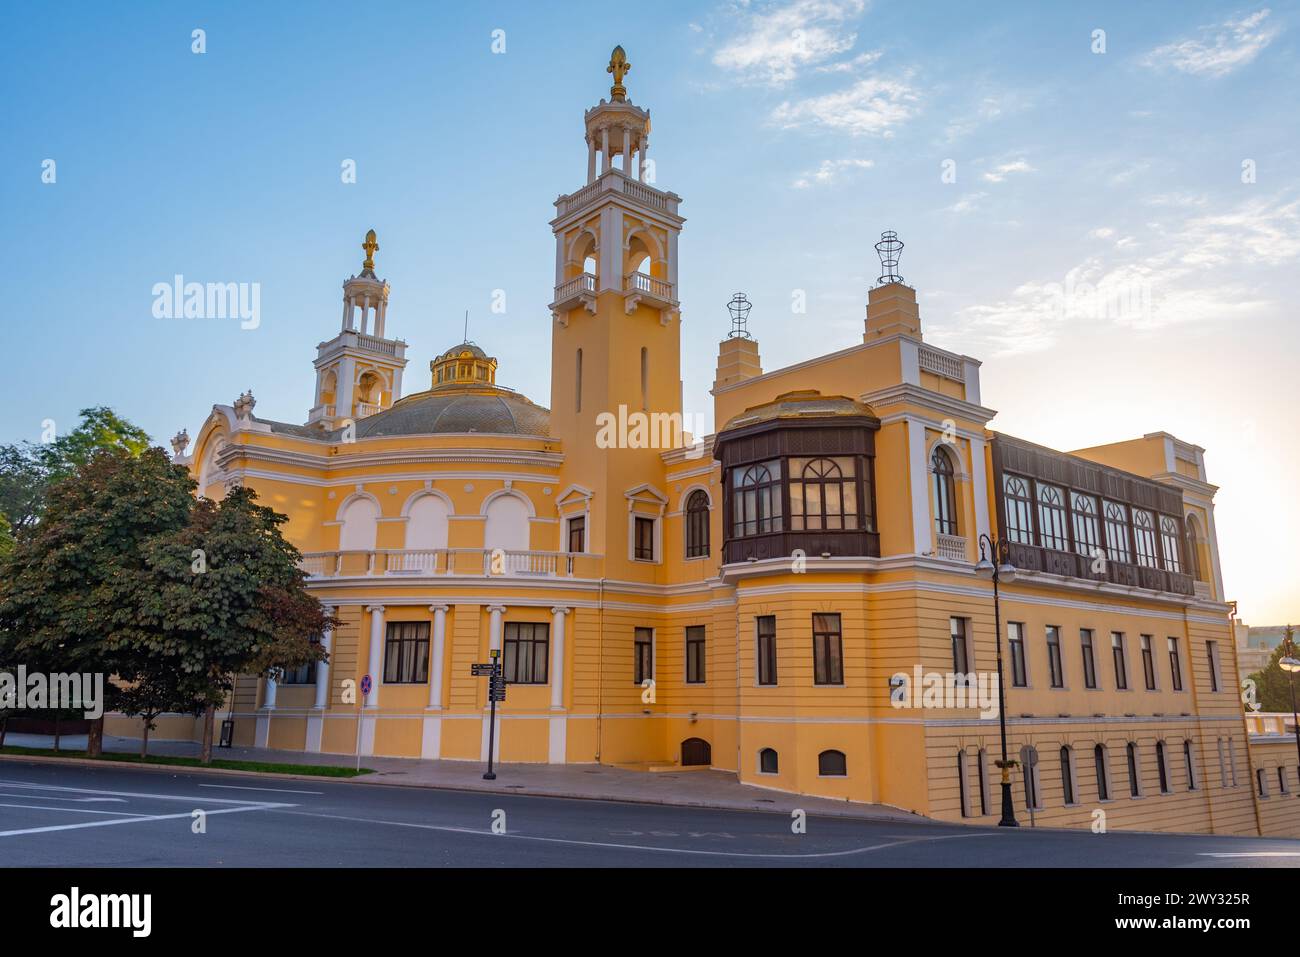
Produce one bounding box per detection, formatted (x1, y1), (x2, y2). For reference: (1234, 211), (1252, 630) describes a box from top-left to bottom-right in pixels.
(140, 488), (334, 763)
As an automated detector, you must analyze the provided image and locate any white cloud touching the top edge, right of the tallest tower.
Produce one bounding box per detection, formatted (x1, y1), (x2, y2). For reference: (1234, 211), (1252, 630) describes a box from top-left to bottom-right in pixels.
(714, 0), (866, 86)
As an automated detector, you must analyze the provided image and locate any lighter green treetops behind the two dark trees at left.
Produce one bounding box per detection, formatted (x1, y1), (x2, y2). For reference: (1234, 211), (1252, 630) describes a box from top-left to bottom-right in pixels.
(0, 406), (150, 534)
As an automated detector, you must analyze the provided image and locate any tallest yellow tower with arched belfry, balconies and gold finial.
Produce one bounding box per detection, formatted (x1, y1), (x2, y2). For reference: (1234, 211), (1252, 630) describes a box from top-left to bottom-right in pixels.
(551, 47), (685, 573)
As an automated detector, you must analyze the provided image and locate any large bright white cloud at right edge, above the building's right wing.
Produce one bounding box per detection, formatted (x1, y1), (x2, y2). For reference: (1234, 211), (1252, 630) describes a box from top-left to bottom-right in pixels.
(949, 191), (1300, 355)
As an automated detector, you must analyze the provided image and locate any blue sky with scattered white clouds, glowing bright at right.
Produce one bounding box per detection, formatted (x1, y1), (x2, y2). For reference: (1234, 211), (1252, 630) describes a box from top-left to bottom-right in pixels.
(0, 0), (1300, 623)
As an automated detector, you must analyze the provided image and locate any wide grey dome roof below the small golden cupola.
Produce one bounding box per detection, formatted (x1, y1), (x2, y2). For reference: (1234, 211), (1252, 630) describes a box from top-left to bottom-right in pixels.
(356, 385), (551, 438)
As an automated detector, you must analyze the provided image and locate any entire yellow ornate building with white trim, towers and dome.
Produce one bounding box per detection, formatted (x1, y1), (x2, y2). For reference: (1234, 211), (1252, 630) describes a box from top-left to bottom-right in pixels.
(117, 49), (1300, 833)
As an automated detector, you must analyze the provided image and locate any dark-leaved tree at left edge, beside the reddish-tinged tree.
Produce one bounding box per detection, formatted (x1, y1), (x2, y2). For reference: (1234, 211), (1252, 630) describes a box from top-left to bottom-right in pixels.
(0, 447), (195, 754)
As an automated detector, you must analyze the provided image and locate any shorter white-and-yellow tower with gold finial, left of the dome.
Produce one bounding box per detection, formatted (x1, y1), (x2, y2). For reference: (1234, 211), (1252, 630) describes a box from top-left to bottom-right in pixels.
(307, 229), (407, 429)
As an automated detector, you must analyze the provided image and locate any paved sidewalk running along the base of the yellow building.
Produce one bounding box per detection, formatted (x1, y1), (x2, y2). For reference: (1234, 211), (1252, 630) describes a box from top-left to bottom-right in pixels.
(5, 735), (927, 822)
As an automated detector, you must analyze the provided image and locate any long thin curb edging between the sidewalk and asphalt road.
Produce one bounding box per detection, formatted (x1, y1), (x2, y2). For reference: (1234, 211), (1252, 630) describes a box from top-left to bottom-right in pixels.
(0, 754), (925, 824)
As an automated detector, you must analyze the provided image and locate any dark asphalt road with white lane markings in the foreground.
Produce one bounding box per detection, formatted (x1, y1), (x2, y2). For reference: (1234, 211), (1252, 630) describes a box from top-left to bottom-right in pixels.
(0, 761), (1300, 867)
